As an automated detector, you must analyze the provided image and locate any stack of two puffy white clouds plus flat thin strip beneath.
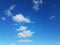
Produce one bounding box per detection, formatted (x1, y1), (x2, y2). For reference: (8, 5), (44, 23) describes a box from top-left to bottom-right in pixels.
(17, 26), (34, 43)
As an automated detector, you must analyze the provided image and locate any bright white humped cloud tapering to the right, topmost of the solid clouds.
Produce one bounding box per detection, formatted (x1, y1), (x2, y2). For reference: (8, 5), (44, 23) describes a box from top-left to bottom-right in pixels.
(12, 14), (31, 23)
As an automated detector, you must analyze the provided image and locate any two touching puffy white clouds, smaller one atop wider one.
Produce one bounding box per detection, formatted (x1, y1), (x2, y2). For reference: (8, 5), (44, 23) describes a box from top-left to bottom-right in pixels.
(17, 26), (34, 38)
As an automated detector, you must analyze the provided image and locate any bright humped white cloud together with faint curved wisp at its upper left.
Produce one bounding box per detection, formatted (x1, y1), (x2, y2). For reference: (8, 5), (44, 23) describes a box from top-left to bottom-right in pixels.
(5, 5), (31, 23)
